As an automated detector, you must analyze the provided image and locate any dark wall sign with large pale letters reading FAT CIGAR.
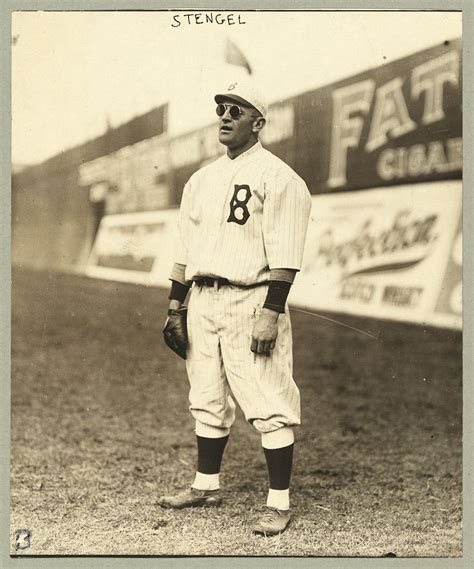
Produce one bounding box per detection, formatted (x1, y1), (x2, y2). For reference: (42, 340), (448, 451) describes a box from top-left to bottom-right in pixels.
(292, 40), (462, 194)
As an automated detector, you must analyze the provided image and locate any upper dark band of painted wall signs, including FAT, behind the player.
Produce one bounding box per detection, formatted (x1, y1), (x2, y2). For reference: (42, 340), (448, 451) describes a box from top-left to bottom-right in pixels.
(79, 40), (462, 214)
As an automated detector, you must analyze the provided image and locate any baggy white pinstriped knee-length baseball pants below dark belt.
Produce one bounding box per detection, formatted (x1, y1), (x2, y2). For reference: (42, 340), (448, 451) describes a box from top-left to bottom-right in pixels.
(186, 285), (300, 437)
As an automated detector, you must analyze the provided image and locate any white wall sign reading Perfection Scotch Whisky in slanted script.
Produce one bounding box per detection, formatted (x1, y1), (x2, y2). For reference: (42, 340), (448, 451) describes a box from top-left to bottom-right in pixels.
(290, 181), (462, 323)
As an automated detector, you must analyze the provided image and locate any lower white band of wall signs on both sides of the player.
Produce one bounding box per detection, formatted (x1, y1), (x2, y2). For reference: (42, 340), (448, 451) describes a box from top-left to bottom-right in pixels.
(87, 181), (462, 328)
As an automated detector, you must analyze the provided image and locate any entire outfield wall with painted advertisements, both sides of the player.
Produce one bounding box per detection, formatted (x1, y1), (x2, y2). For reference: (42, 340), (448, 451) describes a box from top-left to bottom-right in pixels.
(13, 40), (463, 328)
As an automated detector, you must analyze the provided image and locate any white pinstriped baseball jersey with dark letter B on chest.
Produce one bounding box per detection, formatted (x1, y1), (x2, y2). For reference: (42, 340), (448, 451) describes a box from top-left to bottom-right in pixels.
(176, 142), (311, 285)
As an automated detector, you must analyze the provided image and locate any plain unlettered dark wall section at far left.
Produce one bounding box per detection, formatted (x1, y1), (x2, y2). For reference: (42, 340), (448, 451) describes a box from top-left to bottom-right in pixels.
(12, 105), (168, 271)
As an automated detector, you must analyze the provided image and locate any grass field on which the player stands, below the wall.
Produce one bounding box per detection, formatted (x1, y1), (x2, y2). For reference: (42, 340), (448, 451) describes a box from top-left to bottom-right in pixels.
(11, 270), (462, 557)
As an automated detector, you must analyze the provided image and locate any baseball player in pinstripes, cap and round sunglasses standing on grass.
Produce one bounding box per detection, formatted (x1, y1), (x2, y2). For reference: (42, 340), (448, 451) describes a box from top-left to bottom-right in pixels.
(159, 80), (311, 535)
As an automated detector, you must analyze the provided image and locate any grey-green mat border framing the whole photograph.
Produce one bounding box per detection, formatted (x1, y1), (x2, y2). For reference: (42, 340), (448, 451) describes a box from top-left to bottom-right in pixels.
(0, 0), (474, 569)
